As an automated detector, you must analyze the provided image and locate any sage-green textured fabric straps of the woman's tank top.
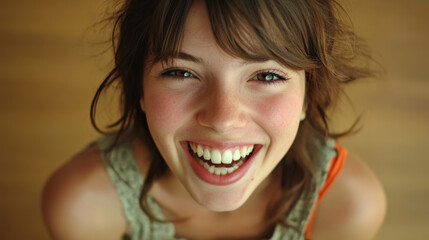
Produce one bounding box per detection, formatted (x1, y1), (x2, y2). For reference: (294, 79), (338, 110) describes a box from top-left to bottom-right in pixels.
(97, 135), (337, 240)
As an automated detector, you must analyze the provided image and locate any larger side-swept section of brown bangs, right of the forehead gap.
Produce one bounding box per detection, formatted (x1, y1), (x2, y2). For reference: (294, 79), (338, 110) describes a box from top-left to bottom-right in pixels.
(206, 0), (315, 70)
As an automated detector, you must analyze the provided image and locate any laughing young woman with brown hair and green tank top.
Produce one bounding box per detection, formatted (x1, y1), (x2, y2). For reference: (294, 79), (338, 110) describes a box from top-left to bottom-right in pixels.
(43, 0), (385, 240)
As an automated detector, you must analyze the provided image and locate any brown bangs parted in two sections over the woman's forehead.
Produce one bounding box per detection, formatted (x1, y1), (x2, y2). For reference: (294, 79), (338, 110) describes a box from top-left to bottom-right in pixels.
(148, 0), (317, 70)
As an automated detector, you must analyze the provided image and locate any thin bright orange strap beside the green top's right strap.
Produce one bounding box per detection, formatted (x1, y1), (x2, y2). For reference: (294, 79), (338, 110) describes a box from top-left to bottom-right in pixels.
(305, 142), (347, 239)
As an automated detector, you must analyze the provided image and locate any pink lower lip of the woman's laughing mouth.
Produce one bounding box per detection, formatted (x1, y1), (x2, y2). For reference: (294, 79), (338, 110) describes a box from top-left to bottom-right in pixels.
(181, 142), (262, 186)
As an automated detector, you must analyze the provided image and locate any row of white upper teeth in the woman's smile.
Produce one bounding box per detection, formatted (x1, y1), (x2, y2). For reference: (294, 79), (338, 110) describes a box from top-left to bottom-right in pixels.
(189, 143), (254, 164)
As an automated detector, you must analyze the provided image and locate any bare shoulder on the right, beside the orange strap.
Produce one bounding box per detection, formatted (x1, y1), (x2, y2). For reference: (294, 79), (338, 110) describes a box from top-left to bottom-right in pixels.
(311, 153), (386, 240)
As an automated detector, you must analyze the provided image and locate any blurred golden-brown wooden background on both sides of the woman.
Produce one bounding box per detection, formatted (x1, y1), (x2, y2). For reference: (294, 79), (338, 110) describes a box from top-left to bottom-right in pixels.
(0, 0), (429, 240)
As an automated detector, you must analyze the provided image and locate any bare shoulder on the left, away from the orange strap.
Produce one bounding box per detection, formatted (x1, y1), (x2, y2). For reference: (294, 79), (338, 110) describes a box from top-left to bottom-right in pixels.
(42, 146), (126, 240)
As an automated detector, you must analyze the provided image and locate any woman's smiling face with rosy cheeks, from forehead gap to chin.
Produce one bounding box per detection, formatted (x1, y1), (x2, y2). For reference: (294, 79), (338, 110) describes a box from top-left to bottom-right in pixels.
(141, 1), (305, 211)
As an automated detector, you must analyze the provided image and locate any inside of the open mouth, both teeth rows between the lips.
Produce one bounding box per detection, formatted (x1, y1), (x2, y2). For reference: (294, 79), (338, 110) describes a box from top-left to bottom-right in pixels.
(188, 142), (255, 176)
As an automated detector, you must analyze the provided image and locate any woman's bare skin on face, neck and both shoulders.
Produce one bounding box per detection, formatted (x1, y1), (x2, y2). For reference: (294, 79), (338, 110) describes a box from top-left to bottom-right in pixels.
(43, 1), (385, 240)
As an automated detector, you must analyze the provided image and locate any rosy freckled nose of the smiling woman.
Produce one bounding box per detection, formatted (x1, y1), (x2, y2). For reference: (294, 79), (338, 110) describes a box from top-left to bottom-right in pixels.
(197, 86), (247, 133)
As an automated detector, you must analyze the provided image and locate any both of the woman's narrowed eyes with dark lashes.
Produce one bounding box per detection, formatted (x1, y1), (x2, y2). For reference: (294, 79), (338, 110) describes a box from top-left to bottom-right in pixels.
(161, 69), (289, 84)
